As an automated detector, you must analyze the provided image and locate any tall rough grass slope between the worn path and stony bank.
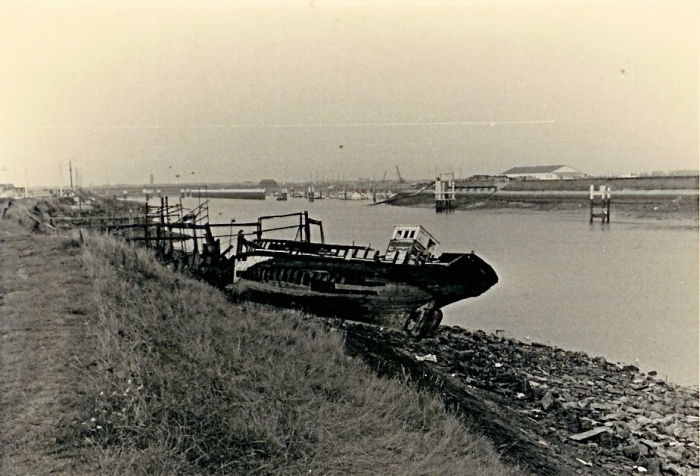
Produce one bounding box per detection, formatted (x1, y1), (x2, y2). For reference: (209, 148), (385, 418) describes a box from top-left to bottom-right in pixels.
(79, 235), (519, 475)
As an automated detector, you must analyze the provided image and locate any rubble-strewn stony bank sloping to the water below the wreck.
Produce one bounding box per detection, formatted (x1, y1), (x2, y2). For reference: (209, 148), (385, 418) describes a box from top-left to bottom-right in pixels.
(324, 320), (698, 475)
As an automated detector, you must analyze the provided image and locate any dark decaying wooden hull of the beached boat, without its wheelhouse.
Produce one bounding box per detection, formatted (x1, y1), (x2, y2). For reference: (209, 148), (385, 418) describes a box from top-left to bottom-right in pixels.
(233, 251), (498, 328)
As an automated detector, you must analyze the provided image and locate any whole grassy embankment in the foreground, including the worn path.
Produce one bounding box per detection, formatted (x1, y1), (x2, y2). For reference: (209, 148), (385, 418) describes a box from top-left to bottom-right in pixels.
(2, 198), (518, 475)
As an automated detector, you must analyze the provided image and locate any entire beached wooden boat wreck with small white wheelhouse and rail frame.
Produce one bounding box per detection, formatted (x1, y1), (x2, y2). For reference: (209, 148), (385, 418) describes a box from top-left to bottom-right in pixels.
(230, 213), (498, 337)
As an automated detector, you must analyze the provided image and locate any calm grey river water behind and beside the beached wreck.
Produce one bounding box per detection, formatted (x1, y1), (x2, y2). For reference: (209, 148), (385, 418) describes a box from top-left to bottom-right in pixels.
(171, 198), (700, 385)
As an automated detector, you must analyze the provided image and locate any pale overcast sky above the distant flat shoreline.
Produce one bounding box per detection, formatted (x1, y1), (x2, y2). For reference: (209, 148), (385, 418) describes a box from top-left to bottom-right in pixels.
(0, 0), (700, 186)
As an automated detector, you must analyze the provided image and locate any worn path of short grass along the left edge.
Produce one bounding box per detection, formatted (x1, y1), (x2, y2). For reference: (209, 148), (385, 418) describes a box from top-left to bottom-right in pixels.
(0, 220), (95, 475)
